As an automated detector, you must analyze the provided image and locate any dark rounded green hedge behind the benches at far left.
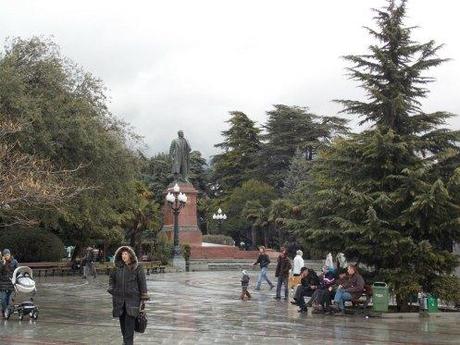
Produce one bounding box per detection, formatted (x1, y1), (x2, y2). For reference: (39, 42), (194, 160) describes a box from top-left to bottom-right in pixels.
(0, 229), (64, 262)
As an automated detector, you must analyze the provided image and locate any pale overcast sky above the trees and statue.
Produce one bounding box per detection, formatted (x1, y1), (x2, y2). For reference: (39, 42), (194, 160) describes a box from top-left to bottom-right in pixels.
(0, 0), (460, 156)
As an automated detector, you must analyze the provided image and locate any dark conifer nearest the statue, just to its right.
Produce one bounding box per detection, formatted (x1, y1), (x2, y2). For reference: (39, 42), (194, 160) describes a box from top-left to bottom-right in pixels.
(212, 111), (261, 194)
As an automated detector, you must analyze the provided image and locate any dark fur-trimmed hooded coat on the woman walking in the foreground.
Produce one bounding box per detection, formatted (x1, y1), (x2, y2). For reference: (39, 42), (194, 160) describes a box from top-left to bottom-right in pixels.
(107, 246), (149, 317)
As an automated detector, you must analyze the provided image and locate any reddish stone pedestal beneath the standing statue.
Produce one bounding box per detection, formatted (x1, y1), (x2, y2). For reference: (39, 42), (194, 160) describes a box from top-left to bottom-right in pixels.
(161, 183), (203, 245)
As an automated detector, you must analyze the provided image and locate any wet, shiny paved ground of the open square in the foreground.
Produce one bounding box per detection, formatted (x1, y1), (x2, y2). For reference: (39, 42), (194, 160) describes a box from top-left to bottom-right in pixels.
(0, 271), (460, 345)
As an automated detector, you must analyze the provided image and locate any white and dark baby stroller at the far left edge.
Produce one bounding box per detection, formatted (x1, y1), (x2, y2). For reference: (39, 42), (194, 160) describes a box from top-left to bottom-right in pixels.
(5, 266), (38, 320)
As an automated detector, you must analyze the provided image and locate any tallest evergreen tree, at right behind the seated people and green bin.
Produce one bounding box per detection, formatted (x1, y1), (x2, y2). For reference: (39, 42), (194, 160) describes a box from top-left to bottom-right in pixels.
(290, 0), (460, 309)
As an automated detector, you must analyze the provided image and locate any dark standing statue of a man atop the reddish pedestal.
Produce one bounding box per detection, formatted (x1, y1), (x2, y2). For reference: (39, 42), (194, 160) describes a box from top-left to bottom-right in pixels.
(169, 131), (192, 182)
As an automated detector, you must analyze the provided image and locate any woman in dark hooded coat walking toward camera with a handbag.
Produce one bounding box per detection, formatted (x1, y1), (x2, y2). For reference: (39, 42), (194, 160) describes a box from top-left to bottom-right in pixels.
(108, 246), (149, 345)
